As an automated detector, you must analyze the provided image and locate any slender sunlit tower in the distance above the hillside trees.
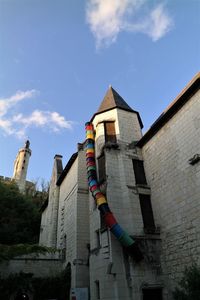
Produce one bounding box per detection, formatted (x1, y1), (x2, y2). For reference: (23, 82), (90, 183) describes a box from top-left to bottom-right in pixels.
(13, 140), (31, 192)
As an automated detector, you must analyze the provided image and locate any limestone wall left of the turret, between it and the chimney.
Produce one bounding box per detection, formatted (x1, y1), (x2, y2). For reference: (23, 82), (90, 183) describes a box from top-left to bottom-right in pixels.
(57, 150), (89, 288)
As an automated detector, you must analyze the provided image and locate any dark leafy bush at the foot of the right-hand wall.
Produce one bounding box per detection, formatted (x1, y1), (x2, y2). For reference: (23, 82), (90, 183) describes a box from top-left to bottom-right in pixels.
(173, 265), (200, 300)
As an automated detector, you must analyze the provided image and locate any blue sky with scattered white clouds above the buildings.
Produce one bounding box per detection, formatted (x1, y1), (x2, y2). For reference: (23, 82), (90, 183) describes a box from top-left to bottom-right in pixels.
(0, 0), (200, 185)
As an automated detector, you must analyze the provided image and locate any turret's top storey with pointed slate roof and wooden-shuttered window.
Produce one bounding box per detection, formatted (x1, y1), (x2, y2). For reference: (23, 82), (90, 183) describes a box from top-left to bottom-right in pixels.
(91, 86), (143, 156)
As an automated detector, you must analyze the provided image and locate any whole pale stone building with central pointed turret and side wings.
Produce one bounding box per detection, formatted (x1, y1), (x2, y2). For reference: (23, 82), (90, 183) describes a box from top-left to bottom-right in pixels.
(40, 73), (200, 300)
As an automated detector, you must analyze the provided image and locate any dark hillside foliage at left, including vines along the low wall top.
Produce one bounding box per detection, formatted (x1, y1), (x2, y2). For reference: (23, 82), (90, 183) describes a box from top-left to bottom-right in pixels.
(0, 181), (50, 262)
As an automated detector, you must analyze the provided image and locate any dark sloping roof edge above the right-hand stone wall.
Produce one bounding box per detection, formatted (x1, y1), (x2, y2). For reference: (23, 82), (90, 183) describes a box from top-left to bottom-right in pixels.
(137, 73), (200, 147)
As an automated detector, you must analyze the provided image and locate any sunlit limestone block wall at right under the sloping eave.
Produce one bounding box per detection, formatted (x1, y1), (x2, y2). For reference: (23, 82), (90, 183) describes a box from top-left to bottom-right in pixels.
(142, 91), (200, 289)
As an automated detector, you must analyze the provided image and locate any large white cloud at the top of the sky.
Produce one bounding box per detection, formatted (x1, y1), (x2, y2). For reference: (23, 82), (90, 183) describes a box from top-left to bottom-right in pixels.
(86, 0), (173, 48)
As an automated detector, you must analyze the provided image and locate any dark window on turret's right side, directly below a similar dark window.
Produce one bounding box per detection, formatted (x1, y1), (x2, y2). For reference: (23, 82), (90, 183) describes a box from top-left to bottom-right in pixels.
(139, 194), (155, 233)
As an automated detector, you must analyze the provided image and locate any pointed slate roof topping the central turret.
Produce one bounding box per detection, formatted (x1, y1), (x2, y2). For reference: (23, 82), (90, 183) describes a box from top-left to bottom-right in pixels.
(91, 86), (143, 128)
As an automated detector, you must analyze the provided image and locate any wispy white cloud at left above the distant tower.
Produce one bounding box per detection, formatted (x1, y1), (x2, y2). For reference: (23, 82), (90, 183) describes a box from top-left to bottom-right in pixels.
(0, 90), (73, 138)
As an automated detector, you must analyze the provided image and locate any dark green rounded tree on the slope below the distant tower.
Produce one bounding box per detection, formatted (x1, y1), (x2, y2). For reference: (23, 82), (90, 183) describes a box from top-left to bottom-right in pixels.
(0, 181), (41, 245)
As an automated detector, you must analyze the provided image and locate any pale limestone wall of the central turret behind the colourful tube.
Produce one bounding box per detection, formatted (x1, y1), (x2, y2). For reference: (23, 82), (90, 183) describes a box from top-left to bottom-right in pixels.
(90, 109), (164, 300)
